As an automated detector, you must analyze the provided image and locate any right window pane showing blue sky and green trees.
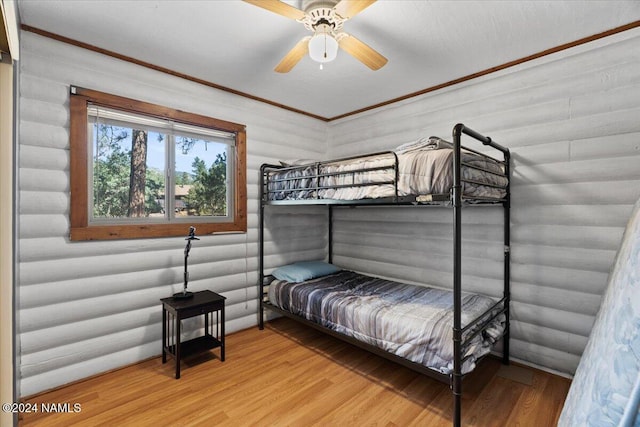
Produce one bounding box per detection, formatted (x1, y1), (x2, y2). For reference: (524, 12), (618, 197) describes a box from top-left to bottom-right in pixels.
(174, 136), (231, 218)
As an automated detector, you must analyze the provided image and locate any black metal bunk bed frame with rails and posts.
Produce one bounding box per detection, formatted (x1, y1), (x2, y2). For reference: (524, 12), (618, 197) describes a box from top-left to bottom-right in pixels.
(258, 123), (511, 427)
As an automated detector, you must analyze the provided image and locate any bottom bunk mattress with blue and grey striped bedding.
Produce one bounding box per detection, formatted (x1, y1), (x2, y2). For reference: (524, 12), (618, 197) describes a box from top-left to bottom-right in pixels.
(269, 270), (505, 374)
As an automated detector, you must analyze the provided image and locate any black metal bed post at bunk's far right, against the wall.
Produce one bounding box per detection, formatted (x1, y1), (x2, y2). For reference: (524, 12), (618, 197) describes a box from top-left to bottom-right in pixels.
(502, 149), (511, 365)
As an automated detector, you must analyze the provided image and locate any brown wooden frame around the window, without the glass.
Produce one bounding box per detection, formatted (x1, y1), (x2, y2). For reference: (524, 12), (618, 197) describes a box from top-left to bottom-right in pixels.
(69, 86), (247, 241)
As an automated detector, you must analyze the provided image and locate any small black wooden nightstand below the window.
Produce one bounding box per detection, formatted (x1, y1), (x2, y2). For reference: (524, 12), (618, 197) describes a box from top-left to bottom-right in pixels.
(160, 291), (226, 379)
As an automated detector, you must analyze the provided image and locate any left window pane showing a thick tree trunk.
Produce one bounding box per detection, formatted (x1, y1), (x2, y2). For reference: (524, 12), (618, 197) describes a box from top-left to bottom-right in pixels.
(92, 122), (166, 220)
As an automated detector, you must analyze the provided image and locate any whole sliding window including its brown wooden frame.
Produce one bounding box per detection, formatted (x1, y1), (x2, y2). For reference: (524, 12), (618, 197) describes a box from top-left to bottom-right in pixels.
(70, 87), (247, 240)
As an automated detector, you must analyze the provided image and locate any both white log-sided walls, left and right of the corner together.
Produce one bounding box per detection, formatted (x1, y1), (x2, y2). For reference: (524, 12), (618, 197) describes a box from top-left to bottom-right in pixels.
(16, 25), (640, 396)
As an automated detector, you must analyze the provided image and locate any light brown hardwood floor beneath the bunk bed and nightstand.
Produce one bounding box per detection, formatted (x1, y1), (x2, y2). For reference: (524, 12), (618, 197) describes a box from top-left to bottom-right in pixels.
(20, 319), (570, 427)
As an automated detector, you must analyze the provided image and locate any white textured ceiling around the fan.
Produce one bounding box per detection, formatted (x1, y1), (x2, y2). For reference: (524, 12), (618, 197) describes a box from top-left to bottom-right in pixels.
(18, 0), (640, 118)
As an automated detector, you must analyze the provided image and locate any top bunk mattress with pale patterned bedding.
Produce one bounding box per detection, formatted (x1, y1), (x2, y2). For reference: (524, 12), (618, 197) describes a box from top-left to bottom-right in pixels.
(265, 137), (508, 201)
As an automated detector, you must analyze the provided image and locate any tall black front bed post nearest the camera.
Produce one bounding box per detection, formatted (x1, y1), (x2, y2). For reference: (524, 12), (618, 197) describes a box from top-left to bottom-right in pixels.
(451, 123), (464, 427)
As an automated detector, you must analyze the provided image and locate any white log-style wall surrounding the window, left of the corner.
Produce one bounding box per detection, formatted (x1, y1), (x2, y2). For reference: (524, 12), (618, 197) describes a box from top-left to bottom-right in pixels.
(16, 32), (327, 396)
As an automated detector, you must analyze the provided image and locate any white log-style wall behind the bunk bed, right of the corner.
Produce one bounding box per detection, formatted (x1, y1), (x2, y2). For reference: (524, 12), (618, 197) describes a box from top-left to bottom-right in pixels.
(328, 29), (640, 374)
